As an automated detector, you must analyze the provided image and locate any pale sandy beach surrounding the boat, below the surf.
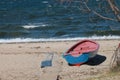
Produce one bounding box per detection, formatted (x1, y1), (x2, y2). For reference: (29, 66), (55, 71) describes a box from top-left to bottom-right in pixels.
(0, 40), (120, 80)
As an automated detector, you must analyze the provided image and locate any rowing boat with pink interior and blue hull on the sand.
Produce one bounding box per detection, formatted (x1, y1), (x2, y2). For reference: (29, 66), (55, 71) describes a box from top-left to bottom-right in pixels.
(63, 40), (99, 66)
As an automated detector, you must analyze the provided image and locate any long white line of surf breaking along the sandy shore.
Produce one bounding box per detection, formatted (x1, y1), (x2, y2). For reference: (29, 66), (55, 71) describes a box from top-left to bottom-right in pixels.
(0, 35), (120, 43)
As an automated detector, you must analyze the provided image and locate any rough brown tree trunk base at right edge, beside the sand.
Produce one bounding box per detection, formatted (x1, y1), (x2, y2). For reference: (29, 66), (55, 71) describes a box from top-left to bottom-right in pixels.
(110, 44), (120, 71)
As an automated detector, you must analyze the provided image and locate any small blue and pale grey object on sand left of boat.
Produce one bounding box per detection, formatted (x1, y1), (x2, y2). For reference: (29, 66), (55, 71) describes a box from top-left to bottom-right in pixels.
(41, 53), (54, 68)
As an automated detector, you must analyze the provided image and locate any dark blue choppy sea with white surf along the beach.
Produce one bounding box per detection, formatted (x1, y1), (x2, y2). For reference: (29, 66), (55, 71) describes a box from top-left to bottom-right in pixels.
(0, 0), (120, 43)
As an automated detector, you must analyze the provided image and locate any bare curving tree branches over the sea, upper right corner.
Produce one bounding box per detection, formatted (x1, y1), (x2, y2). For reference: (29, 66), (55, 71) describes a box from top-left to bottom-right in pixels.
(60, 0), (120, 21)
